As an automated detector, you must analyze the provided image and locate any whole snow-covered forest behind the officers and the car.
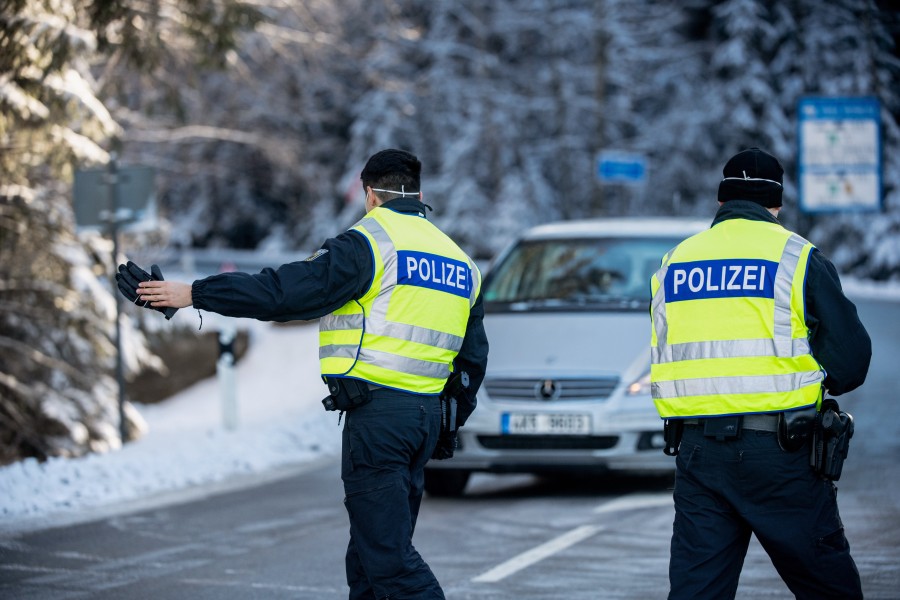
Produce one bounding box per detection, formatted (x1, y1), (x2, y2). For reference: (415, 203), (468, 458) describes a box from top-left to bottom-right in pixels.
(0, 0), (900, 465)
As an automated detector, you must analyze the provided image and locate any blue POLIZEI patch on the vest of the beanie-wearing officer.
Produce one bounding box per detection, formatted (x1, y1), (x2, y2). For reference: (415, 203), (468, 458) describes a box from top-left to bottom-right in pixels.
(665, 258), (778, 302)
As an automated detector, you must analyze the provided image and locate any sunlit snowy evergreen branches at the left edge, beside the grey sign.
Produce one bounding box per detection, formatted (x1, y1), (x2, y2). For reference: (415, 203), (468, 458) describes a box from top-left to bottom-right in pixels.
(0, 0), (260, 463)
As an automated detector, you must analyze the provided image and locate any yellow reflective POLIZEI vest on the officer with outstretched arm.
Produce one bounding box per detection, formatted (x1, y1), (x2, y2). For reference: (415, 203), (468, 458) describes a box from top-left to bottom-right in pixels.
(319, 207), (481, 394)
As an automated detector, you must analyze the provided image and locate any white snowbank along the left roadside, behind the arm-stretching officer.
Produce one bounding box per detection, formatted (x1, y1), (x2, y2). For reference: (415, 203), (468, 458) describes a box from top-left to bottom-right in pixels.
(0, 313), (340, 530)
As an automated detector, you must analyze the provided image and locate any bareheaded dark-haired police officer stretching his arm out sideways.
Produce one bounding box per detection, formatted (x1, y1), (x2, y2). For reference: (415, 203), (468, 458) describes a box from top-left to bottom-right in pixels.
(128, 149), (488, 600)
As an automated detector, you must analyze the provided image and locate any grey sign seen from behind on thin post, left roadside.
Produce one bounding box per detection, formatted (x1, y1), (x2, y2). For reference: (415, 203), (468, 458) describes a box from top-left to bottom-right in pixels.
(72, 153), (156, 446)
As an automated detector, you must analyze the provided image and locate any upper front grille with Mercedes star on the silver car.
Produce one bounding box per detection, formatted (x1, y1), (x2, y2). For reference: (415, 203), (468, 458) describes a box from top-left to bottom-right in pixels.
(484, 377), (619, 402)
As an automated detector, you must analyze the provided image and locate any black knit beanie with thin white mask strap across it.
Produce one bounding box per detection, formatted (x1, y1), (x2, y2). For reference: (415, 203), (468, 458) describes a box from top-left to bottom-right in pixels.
(719, 148), (784, 208)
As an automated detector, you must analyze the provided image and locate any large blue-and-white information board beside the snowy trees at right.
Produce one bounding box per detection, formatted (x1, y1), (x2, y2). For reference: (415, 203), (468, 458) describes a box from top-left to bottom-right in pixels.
(797, 97), (881, 213)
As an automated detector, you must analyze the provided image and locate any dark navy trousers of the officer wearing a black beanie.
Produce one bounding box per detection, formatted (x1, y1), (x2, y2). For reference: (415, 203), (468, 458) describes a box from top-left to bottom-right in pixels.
(669, 426), (862, 600)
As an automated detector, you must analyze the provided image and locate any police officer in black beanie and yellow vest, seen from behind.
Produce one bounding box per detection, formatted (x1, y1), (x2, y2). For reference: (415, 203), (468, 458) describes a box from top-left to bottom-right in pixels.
(651, 148), (871, 600)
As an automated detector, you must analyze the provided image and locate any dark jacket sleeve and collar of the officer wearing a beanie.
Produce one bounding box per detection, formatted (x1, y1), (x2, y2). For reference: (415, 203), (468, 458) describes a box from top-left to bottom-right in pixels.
(712, 200), (872, 396)
